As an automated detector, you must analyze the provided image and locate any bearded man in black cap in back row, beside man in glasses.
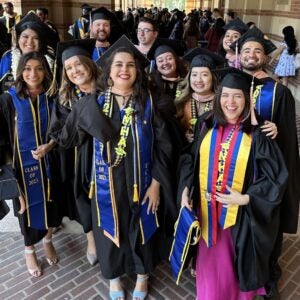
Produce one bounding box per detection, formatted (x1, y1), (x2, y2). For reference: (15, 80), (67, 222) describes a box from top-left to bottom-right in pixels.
(90, 7), (124, 61)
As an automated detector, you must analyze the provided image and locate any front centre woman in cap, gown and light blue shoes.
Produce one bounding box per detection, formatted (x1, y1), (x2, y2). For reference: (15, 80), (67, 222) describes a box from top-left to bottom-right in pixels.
(49, 36), (176, 299)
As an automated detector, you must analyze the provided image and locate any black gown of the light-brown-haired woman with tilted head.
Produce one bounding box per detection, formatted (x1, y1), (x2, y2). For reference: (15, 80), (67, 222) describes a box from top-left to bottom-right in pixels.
(48, 101), (79, 226)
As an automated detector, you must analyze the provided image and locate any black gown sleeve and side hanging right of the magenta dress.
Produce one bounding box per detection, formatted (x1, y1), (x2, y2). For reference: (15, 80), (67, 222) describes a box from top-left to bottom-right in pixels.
(232, 129), (288, 291)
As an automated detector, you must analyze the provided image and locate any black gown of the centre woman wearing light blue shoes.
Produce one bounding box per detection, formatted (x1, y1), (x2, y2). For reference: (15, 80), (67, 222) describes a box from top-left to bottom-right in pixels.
(49, 95), (176, 278)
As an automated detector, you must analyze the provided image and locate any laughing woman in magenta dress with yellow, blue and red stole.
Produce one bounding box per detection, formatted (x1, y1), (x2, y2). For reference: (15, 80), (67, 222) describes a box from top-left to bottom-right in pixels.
(178, 69), (288, 300)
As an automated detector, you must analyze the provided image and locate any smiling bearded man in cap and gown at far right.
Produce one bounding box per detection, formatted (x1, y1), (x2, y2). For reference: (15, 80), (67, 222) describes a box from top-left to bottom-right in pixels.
(232, 27), (300, 299)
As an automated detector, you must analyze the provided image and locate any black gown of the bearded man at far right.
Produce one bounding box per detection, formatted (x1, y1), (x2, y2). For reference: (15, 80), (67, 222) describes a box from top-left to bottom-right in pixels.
(260, 77), (300, 233)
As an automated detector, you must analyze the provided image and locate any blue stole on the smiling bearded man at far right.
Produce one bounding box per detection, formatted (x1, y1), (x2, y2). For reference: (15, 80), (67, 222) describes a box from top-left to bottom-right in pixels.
(253, 80), (277, 121)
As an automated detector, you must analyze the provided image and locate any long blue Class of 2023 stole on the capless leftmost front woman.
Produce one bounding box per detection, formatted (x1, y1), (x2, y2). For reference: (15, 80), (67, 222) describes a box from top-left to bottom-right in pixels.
(8, 88), (51, 230)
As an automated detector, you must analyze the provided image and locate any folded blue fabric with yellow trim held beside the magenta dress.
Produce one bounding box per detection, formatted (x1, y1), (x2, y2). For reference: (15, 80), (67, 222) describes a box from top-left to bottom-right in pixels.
(169, 207), (201, 285)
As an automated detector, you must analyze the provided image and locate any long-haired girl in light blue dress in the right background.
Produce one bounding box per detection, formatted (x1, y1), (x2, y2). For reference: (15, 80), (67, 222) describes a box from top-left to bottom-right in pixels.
(270, 26), (298, 86)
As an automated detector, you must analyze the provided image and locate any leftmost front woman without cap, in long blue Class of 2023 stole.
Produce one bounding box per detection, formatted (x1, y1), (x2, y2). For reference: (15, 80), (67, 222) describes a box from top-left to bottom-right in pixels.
(0, 52), (61, 277)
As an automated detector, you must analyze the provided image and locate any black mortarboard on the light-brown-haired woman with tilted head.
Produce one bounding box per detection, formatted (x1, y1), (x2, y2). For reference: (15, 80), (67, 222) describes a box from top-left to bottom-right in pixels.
(56, 39), (96, 65)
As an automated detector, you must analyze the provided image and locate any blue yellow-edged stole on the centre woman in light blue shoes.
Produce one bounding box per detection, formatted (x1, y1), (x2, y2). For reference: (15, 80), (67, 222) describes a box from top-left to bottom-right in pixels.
(93, 95), (159, 247)
